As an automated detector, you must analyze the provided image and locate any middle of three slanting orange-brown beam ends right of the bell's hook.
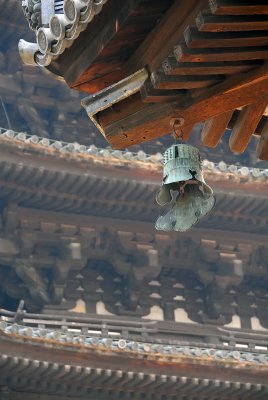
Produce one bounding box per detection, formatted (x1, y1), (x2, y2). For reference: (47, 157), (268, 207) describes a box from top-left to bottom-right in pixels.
(229, 96), (268, 153)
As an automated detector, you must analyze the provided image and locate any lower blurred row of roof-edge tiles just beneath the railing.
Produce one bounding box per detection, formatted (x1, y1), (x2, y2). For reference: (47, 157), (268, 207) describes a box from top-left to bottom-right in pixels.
(0, 320), (268, 368)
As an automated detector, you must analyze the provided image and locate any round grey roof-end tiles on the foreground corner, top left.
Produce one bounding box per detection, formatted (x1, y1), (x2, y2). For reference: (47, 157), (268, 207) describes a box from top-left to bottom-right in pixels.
(19, 0), (107, 67)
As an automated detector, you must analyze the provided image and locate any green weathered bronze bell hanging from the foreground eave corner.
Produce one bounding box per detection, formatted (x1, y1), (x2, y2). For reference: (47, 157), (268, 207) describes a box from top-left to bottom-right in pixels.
(155, 144), (216, 232)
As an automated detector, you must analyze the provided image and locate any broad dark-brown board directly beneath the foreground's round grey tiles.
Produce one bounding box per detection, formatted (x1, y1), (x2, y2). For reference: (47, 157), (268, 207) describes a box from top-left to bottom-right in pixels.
(59, 0), (172, 93)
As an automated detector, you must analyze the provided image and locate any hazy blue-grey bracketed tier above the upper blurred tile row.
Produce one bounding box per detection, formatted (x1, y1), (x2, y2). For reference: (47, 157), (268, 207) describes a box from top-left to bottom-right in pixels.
(0, 0), (266, 168)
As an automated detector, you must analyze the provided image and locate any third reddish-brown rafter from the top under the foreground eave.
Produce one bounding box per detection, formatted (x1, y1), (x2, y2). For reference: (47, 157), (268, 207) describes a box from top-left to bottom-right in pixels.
(184, 27), (268, 49)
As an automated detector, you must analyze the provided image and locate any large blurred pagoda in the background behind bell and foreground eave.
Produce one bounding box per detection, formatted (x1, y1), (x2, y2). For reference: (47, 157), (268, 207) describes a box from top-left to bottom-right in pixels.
(0, 0), (268, 400)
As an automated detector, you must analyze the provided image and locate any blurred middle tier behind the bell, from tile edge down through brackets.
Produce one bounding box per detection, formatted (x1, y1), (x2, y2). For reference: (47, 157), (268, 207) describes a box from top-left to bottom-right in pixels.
(0, 130), (267, 318)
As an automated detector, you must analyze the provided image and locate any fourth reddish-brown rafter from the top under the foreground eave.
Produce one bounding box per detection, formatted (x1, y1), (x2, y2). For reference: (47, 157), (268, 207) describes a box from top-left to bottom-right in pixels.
(174, 44), (268, 63)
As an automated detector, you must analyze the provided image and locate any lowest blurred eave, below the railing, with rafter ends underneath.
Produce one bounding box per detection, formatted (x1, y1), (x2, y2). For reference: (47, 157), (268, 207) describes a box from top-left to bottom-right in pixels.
(0, 327), (268, 400)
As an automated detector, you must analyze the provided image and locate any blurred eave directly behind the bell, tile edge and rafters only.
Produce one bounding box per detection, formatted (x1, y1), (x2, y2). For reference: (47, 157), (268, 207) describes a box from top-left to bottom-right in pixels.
(0, 137), (267, 234)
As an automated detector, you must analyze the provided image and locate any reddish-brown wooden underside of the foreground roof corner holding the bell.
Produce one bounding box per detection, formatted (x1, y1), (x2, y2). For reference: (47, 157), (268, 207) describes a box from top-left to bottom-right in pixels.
(49, 0), (268, 160)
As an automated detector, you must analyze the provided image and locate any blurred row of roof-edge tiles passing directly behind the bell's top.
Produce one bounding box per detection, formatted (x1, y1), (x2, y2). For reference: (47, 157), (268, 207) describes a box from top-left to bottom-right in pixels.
(0, 128), (268, 184)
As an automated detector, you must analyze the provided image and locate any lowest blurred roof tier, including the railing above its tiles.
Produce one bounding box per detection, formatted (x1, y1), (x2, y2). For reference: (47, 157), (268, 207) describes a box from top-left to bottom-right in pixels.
(0, 310), (268, 400)
